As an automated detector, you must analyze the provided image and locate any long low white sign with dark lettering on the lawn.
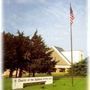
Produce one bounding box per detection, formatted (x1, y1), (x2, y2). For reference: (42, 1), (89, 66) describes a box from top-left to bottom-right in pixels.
(12, 76), (53, 89)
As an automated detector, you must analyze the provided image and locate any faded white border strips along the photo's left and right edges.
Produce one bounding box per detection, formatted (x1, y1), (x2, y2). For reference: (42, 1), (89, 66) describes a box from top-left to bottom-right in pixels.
(0, 0), (90, 90)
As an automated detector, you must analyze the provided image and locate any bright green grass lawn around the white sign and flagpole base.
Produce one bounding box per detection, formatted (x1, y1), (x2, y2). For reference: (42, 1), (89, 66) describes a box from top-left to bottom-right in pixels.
(3, 77), (87, 90)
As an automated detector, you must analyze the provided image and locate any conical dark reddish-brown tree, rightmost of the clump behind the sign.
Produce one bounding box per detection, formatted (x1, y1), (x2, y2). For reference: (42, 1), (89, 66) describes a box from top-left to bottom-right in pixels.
(30, 31), (56, 76)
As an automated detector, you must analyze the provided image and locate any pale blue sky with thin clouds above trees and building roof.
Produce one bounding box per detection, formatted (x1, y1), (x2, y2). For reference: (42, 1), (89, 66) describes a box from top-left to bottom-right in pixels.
(3, 0), (87, 55)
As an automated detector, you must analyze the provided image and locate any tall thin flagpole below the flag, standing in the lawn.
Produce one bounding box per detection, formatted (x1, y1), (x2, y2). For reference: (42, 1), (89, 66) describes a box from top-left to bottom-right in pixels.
(70, 23), (74, 86)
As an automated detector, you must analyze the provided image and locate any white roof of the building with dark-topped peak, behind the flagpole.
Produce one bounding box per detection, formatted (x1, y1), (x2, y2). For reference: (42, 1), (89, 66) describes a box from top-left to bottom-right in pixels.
(52, 46), (84, 63)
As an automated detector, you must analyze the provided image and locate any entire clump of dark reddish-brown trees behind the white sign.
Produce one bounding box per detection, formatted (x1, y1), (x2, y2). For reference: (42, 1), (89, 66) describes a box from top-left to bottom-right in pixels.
(3, 31), (56, 77)
